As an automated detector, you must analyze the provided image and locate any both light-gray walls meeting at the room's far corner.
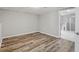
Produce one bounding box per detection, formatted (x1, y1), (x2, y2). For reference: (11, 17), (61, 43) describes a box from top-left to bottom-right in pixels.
(0, 10), (59, 37)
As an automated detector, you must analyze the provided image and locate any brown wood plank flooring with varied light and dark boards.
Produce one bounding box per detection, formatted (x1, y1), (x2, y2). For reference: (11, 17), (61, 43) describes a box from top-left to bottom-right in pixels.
(0, 32), (74, 52)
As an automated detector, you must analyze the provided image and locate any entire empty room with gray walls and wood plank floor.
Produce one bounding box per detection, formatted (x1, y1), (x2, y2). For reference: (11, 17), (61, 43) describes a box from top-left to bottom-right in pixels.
(0, 7), (79, 52)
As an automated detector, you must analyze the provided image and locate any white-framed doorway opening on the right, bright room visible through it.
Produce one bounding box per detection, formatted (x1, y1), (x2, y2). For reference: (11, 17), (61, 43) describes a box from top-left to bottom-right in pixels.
(59, 9), (75, 41)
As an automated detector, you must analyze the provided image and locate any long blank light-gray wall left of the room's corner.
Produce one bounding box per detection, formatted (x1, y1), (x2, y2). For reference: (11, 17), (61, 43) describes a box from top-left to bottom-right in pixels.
(0, 10), (37, 37)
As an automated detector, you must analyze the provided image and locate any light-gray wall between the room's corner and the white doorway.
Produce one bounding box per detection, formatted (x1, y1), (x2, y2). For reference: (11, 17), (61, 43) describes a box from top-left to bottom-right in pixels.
(40, 10), (59, 36)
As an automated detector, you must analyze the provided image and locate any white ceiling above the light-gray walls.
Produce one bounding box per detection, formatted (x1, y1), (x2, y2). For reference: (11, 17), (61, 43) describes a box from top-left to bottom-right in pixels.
(0, 7), (74, 14)
